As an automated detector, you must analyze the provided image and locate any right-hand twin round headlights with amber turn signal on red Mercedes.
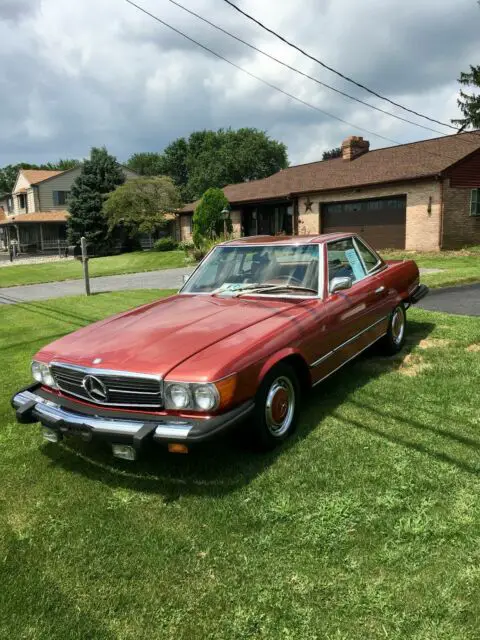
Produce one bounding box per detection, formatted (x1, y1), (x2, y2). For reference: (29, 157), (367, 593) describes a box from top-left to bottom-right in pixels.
(164, 374), (237, 411)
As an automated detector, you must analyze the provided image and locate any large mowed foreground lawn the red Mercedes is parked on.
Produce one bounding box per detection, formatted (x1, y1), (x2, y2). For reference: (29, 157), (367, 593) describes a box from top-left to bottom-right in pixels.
(0, 291), (480, 640)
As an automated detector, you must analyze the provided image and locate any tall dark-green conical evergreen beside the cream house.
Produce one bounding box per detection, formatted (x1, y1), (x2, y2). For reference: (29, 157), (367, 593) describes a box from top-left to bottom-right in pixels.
(67, 147), (125, 253)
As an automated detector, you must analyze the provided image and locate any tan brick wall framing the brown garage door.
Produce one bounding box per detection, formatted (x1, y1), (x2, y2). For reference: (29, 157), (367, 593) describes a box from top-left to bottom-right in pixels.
(298, 180), (442, 251)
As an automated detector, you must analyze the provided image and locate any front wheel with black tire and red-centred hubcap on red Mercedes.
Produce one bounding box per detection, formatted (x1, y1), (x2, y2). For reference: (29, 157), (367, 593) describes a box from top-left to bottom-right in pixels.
(251, 363), (300, 451)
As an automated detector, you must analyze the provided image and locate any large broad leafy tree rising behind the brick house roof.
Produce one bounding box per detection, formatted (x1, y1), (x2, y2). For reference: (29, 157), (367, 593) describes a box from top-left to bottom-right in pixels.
(156, 128), (288, 201)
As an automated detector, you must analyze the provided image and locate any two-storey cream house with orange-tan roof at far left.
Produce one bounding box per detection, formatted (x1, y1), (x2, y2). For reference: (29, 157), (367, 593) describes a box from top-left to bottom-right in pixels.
(0, 167), (138, 251)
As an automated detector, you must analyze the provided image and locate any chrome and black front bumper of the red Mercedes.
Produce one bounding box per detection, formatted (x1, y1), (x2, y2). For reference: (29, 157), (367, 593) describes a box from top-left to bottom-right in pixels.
(11, 384), (254, 451)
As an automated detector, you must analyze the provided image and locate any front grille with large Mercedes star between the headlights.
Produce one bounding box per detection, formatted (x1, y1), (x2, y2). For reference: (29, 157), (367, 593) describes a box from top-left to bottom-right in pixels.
(50, 362), (163, 409)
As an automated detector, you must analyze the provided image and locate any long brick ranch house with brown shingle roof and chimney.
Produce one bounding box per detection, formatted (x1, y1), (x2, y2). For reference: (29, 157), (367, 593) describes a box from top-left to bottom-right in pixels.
(179, 131), (480, 251)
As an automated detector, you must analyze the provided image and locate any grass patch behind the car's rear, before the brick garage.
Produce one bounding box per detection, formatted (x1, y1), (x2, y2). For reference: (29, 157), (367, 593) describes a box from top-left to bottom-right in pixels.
(380, 245), (480, 289)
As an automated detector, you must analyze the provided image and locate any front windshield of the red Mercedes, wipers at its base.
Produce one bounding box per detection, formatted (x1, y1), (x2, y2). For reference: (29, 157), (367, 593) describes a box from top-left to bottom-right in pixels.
(182, 244), (319, 296)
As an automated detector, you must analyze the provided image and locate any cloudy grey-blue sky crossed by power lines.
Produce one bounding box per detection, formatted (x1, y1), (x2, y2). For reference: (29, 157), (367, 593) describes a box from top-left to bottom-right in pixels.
(0, 0), (480, 166)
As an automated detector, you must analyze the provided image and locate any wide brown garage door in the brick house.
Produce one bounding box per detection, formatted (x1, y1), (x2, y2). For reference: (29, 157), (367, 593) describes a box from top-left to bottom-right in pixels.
(321, 196), (406, 249)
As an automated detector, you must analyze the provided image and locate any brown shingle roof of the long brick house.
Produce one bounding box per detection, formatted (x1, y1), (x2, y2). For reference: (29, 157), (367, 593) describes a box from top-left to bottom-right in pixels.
(182, 132), (480, 213)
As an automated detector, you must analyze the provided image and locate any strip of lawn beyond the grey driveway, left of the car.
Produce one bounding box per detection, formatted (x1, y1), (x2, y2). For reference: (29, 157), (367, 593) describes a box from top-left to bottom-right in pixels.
(0, 251), (186, 287)
